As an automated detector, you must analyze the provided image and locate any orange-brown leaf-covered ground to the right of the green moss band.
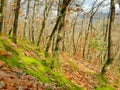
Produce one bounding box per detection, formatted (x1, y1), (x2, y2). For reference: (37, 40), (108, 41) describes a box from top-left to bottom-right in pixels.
(62, 52), (120, 90)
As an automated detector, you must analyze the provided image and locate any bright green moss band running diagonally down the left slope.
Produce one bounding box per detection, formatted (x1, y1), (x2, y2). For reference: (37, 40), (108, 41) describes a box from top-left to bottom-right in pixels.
(0, 39), (82, 90)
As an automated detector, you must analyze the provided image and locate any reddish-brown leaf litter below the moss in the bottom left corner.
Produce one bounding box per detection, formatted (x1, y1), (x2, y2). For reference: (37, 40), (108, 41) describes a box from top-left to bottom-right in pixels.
(0, 61), (45, 90)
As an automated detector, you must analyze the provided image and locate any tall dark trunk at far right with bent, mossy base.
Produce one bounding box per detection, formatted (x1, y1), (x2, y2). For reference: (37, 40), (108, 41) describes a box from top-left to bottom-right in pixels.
(101, 0), (115, 78)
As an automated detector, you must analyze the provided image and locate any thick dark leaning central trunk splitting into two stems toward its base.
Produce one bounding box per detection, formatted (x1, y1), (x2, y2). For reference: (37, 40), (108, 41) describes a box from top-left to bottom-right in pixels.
(45, 0), (71, 55)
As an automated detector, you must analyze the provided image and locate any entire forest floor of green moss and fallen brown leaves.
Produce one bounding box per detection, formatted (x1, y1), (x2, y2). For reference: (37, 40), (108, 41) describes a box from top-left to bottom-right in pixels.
(0, 36), (120, 90)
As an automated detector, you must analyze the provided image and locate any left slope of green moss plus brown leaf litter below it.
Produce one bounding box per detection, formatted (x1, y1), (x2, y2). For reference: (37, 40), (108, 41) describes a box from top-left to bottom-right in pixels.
(0, 36), (81, 90)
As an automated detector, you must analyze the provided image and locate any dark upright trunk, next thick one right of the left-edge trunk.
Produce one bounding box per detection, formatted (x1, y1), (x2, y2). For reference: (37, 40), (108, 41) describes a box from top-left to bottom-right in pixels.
(13, 0), (21, 43)
